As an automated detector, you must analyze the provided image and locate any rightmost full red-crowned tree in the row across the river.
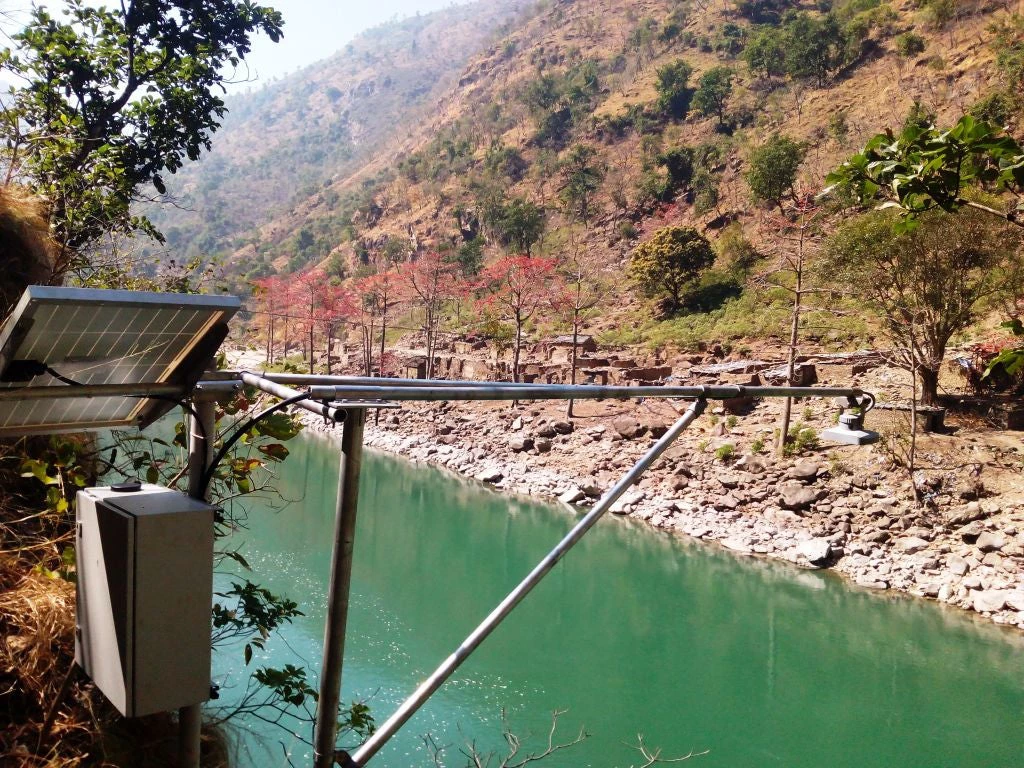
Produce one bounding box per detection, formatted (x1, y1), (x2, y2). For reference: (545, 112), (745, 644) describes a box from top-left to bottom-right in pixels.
(479, 256), (559, 382)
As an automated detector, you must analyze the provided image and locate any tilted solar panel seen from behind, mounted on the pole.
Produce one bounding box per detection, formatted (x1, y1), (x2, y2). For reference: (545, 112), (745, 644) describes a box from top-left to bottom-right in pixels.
(0, 286), (240, 436)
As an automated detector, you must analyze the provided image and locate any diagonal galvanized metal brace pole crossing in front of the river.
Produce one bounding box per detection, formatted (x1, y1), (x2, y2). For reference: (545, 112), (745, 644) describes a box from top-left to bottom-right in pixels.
(348, 399), (707, 768)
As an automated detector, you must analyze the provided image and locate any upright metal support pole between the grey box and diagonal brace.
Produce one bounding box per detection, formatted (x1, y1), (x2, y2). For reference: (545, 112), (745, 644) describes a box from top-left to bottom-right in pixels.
(313, 409), (367, 768)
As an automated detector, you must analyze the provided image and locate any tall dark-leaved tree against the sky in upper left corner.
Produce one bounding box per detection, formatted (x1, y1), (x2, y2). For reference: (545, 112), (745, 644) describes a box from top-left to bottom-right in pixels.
(0, 0), (282, 272)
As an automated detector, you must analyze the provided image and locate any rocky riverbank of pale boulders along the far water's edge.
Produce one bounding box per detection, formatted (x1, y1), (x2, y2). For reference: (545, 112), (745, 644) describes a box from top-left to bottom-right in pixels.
(290, 402), (1024, 629)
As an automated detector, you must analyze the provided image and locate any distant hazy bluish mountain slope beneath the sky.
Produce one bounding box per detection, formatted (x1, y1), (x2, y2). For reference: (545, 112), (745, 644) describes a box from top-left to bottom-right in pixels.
(151, 0), (531, 255)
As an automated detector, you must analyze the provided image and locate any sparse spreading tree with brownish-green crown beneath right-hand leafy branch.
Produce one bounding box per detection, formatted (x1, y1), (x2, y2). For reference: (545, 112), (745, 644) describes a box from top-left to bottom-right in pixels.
(821, 208), (1024, 406)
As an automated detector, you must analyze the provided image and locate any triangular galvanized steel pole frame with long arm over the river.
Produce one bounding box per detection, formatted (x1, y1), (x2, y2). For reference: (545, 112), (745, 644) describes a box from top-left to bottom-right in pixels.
(227, 372), (874, 768)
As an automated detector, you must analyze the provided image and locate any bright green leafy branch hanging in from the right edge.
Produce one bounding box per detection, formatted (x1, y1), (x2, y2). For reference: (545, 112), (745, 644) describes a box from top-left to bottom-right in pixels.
(825, 115), (1024, 228)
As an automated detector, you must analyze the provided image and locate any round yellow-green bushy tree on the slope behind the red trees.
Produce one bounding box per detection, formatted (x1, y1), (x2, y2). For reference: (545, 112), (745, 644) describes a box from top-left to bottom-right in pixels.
(629, 226), (715, 312)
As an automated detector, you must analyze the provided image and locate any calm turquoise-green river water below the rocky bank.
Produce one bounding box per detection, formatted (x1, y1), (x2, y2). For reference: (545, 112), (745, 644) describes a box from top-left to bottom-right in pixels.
(214, 437), (1024, 768)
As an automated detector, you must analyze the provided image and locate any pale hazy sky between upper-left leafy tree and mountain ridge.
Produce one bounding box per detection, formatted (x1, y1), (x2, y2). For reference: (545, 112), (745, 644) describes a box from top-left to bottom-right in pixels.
(229, 0), (466, 87)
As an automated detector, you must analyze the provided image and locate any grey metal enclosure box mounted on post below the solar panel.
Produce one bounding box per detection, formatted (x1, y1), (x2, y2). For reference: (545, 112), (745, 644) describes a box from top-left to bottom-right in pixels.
(75, 484), (214, 717)
